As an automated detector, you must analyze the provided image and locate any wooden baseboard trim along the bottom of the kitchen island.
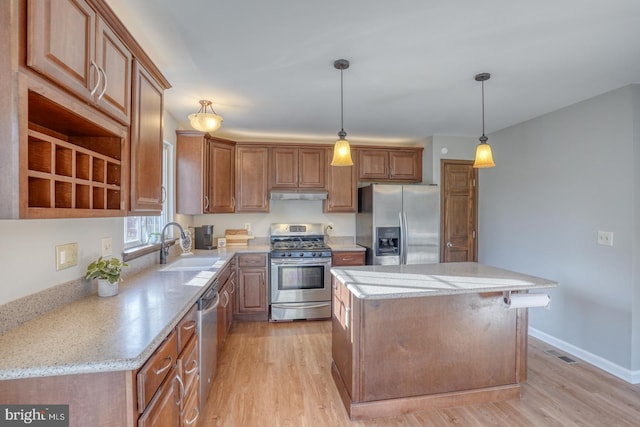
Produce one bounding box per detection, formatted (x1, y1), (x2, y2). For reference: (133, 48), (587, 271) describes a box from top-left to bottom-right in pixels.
(331, 363), (520, 421)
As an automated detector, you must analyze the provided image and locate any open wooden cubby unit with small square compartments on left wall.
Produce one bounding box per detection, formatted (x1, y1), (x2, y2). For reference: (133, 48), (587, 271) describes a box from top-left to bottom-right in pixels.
(26, 93), (124, 217)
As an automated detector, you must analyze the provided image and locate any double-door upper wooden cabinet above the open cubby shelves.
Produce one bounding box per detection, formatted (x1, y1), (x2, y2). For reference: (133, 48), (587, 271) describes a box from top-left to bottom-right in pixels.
(27, 0), (132, 124)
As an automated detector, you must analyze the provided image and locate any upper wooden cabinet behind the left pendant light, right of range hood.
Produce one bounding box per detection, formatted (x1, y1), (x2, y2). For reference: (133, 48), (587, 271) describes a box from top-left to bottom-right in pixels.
(322, 147), (358, 213)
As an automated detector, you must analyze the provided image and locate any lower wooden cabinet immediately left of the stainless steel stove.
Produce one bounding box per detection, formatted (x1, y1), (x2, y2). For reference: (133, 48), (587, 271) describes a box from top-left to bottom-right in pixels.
(233, 253), (269, 321)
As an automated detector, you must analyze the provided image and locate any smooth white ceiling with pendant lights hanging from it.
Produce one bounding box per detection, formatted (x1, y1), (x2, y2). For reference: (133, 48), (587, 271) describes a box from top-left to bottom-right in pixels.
(107, 0), (640, 144)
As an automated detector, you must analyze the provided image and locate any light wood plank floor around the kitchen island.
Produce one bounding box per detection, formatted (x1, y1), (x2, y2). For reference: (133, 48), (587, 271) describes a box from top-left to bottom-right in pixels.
(200, 321), (640, 427)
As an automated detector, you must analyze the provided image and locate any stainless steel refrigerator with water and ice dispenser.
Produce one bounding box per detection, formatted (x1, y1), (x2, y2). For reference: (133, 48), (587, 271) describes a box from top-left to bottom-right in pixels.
(356, 184), (440, 265)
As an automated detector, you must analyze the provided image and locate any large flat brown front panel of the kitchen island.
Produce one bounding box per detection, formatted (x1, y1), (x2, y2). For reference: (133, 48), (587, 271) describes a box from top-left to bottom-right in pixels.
(359, 293), (518, 401)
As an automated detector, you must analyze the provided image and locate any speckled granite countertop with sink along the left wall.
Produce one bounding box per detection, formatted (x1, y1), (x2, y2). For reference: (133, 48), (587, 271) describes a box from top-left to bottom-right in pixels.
(0, 245), (269, 380)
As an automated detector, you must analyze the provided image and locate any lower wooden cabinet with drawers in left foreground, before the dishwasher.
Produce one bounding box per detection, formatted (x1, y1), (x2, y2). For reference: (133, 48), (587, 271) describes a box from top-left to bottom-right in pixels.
(0, 305), (200, 427)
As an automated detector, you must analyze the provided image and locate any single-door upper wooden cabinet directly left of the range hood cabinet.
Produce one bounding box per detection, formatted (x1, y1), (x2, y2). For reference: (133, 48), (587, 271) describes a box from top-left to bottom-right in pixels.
(236, 145), (269, 212)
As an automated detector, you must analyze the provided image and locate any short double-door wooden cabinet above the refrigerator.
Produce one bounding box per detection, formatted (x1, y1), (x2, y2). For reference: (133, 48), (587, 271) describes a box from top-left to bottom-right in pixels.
(357, 147), (423, 182)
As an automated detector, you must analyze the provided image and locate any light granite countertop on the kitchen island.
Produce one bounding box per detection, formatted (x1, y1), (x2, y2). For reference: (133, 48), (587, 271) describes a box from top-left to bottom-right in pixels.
(331, 262), (558, 299)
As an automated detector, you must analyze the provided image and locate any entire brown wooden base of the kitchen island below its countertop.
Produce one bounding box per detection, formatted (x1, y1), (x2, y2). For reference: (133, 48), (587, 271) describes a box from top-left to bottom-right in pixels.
(331, 276), (527, 419)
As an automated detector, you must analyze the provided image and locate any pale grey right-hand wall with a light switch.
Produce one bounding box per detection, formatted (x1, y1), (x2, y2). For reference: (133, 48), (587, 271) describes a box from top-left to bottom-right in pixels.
(479, 86), (640, 374)
